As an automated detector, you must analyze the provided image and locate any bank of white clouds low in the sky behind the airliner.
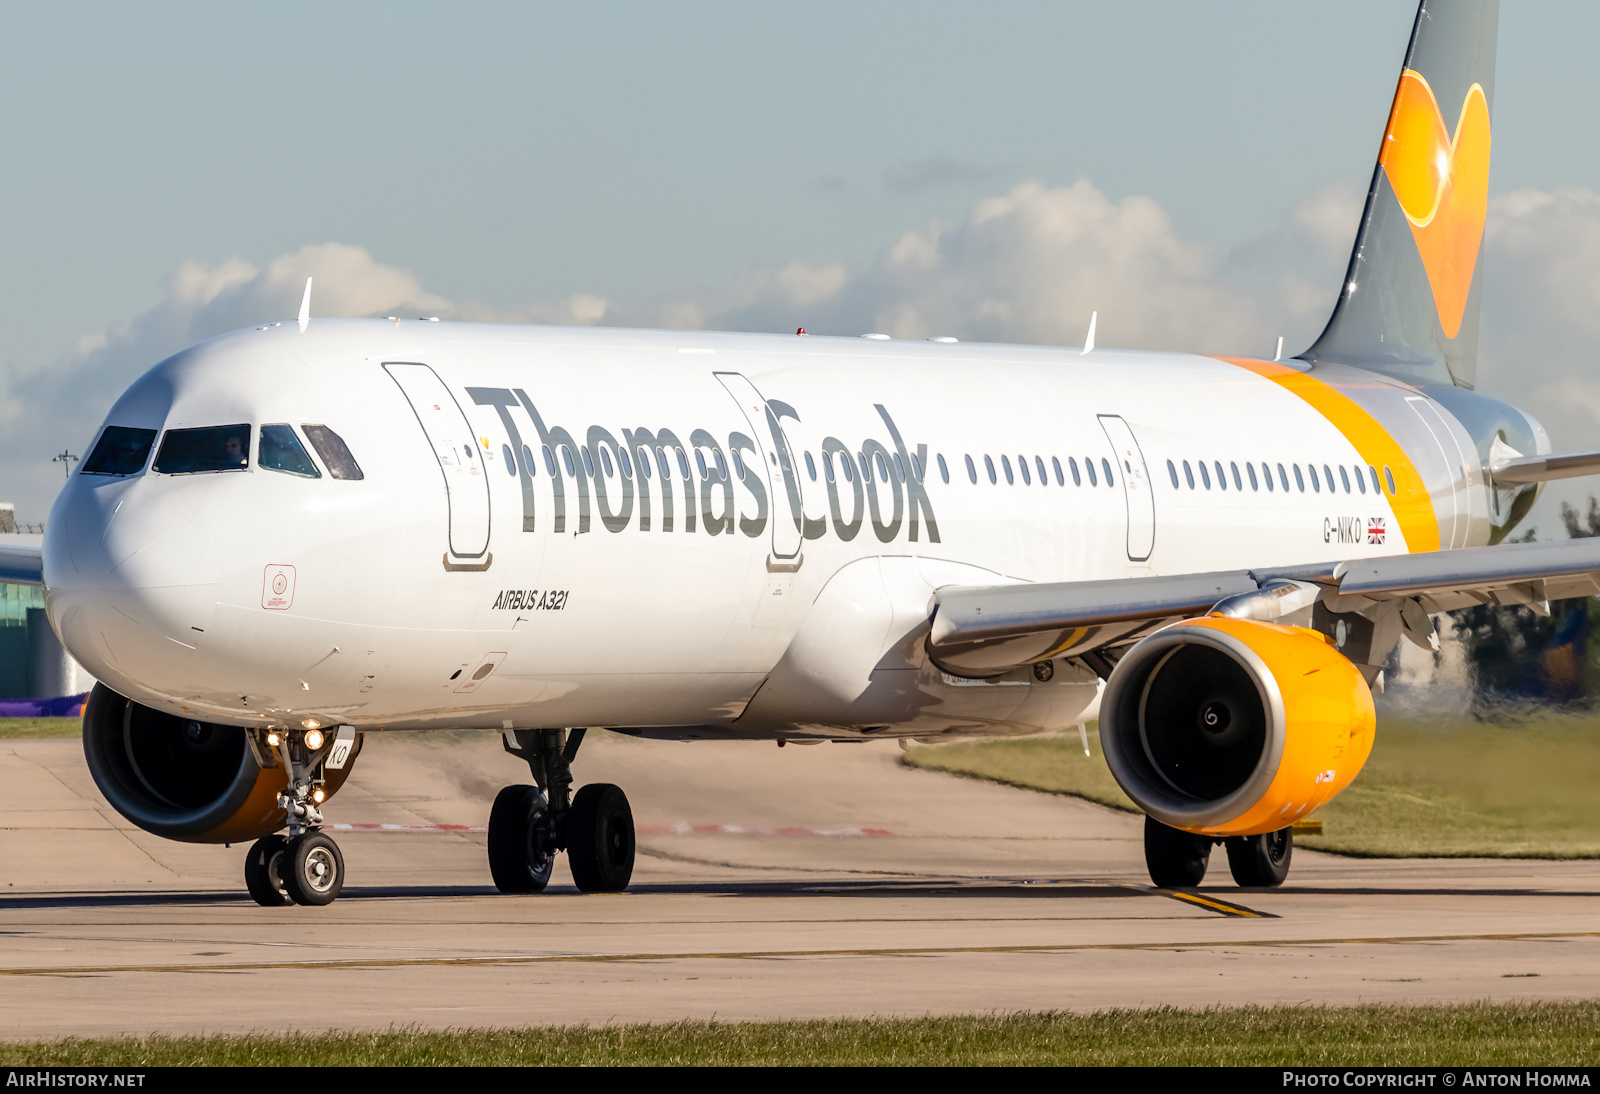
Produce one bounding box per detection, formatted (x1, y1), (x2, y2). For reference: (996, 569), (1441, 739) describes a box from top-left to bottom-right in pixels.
(9, 181), (1600, 533)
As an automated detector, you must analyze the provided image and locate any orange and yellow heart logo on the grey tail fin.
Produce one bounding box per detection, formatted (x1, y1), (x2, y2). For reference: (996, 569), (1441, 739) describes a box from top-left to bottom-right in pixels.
(1379, 69), (1490, 337)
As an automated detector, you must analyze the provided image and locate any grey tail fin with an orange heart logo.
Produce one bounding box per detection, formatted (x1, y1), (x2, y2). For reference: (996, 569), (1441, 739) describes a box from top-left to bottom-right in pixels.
(1301, 0), (1499, 387)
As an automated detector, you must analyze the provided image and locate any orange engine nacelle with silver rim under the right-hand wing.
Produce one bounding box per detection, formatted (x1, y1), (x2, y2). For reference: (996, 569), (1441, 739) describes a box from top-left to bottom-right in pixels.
(1101, 616), (1376, 836)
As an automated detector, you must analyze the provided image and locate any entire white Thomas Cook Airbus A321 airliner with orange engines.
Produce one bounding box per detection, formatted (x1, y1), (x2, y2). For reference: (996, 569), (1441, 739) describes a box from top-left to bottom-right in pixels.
(3, 0), (1600, 905)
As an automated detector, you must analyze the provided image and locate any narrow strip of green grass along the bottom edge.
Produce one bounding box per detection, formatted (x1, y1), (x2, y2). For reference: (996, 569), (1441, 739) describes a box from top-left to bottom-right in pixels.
(0, 1001), (1600, 1067)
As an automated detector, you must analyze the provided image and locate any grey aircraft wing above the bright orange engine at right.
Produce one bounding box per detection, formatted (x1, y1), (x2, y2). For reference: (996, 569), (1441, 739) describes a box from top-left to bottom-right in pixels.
(928, 539), (1600, 675)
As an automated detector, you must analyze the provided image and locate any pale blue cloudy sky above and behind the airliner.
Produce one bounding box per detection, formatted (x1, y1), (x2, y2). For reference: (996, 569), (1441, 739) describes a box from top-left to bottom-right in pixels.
(0, 0), (1600, 523)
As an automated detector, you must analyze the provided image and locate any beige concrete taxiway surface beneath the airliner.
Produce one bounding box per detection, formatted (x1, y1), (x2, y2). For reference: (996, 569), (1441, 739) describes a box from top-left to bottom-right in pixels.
(0, 734), (1600, 1040)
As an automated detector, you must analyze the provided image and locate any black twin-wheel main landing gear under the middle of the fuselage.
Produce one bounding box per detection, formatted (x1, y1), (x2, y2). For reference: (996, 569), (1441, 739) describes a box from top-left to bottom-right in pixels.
(490, 729), (634, 892)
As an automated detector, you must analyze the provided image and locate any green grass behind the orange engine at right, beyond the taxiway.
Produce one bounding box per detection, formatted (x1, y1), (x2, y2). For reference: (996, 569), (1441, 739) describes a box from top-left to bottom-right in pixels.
(906, 715), (1600, 859)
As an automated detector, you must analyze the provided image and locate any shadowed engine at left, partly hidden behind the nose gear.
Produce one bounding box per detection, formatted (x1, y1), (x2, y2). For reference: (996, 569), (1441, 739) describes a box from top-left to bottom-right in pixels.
(83, 685), (360, 843)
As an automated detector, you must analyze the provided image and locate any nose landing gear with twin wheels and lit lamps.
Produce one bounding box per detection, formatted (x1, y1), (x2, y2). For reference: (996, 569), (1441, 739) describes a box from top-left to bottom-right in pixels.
(245, 731), (355, 908)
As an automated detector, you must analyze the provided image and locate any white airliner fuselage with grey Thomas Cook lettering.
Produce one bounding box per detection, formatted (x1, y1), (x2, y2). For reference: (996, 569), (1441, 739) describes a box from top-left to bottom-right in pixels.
(45, 320), (1523, 736)
